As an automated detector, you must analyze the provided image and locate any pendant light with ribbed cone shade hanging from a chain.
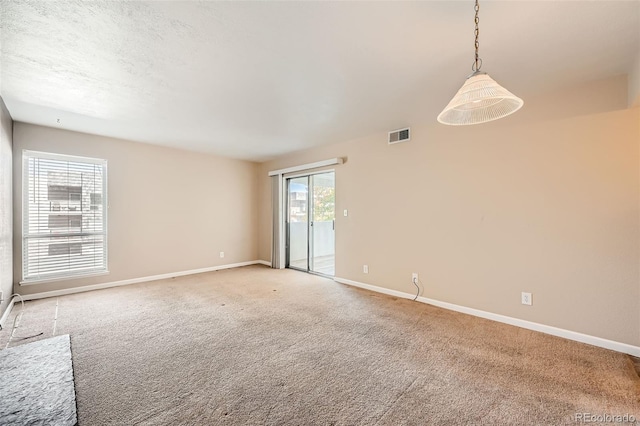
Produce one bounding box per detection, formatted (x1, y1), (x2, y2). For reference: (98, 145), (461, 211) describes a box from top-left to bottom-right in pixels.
(438, 0), (524, 126)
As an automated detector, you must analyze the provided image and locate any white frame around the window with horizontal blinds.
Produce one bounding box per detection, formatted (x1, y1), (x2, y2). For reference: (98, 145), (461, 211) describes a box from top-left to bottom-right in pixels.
(20, 149), (109, 285)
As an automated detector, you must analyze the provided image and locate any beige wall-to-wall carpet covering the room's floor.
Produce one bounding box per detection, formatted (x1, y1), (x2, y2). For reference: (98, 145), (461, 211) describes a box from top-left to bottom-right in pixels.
(0, 266), (640, 426)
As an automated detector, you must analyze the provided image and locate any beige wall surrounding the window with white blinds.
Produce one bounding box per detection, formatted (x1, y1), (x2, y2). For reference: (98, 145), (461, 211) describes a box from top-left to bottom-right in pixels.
(13, 123), (258, 294)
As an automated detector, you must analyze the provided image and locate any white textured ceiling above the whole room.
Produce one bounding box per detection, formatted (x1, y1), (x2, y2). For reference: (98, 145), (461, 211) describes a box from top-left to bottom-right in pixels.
(0, 0), (640, 161)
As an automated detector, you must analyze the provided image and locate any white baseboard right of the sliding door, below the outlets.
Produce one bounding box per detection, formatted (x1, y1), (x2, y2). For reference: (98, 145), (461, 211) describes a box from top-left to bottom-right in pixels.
(334, 277), (640, 357)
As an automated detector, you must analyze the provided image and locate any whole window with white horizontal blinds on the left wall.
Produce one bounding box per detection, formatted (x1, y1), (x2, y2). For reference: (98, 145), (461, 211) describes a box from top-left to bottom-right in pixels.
(22, 151), (107, 284)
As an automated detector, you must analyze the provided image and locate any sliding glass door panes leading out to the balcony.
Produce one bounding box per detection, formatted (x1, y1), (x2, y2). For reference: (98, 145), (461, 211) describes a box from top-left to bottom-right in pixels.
(286, 172), (335, 276)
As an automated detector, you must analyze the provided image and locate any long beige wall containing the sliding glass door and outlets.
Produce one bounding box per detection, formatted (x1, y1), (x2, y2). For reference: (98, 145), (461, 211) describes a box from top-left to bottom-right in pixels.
(259, 77), (640, 345)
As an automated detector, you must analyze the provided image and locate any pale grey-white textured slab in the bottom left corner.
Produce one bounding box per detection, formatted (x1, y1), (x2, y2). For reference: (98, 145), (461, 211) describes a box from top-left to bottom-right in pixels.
(0, 334), (78, 426)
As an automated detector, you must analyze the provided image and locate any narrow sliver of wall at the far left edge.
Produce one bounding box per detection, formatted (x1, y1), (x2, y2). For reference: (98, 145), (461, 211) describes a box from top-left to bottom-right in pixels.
(0, 98), (13, 316)
